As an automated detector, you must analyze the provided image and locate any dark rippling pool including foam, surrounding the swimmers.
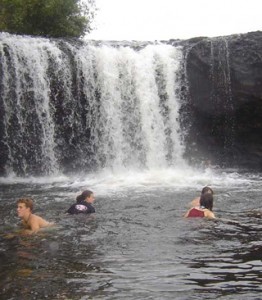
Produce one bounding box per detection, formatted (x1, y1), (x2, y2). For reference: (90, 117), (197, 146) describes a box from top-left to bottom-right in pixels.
(0, 173), (262, 299)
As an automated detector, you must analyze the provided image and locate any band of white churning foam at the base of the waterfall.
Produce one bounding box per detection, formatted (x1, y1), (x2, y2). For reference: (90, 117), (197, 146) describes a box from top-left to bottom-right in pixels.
(0, 167), (262, 195)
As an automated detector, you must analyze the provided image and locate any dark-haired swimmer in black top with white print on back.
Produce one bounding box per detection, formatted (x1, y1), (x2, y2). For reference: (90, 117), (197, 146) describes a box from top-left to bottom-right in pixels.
(67, 190), (95, 215)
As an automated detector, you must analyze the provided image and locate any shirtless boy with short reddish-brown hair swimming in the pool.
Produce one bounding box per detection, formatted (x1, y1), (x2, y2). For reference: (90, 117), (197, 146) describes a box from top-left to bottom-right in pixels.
(17, 198), (53, 234)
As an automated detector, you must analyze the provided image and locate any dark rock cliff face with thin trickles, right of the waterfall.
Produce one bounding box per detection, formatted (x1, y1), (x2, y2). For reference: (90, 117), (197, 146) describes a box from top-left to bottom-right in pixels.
(185, 32), (262, 170)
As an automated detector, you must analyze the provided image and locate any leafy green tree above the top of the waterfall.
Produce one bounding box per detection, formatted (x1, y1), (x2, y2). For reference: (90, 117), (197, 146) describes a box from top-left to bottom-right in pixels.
(0, 0), (95, 37)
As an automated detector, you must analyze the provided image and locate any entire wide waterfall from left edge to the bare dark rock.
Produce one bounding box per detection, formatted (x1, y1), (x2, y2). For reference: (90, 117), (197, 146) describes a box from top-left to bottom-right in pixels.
(0, 33), (184, 176)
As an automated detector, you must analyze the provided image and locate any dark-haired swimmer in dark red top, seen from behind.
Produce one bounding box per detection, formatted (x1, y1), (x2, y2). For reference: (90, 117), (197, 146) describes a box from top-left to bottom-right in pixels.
(184, 193), (215, 219)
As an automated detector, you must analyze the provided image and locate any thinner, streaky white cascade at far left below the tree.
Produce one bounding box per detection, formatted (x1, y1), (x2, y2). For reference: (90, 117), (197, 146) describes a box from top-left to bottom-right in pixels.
(0, 35), (61, 173)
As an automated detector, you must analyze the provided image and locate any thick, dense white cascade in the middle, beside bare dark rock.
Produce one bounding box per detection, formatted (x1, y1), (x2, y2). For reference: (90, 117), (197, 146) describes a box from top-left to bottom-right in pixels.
(73, 45), (186, 170)
